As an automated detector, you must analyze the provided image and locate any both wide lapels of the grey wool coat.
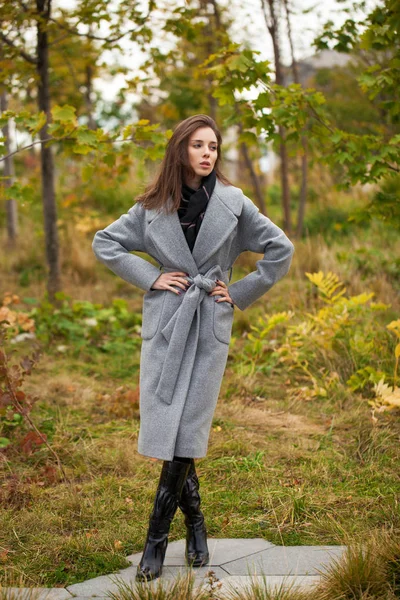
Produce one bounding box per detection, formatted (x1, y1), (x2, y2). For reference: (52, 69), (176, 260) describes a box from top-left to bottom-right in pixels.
(147, 179), (242, 274)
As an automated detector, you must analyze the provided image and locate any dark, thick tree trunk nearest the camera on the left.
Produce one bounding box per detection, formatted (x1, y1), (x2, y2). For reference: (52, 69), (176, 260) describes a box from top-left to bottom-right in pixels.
(36, 0), (60, 302)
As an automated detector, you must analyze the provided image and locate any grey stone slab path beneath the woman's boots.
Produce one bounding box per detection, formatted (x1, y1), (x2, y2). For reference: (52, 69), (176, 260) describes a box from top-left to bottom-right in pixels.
(2, 538), (346, 600)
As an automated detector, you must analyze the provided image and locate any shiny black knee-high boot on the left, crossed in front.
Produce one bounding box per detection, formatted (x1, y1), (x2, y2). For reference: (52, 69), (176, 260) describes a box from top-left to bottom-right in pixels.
(136, 460), (190, 581)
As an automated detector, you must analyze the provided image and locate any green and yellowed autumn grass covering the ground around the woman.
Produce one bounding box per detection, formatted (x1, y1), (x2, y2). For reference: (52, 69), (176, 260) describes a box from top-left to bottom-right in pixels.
(0, 202), (400, 600)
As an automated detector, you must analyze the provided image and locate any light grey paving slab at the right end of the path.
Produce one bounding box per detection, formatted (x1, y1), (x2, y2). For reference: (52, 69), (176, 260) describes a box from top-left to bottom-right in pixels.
(221, 546), (346, 575)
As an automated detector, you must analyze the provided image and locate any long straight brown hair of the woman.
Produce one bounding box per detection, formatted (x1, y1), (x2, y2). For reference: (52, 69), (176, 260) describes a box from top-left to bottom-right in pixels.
(136, 115), (232, 212)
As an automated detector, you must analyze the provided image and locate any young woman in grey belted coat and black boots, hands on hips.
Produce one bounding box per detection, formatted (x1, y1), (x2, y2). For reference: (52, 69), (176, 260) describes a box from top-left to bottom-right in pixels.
(92, 115), (294, 580)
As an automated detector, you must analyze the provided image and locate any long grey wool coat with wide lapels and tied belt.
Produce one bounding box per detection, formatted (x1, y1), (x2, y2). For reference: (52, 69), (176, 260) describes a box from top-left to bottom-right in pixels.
(92, 178), (294, 460)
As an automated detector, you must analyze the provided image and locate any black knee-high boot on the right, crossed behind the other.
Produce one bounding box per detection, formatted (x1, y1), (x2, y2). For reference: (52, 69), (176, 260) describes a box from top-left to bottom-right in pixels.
(178, 458), (209, 567)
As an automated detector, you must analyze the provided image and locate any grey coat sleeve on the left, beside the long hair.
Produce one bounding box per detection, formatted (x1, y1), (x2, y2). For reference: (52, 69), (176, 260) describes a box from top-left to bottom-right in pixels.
(92, 202), (161, 291)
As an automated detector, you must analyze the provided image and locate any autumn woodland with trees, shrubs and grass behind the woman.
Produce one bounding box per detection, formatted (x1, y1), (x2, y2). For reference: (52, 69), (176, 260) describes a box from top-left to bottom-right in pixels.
(0, 0), (400, 597)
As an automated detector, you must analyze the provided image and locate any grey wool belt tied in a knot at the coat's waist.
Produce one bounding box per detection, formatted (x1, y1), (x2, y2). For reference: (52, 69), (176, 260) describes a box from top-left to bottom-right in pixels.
(156, 265), (229, 404)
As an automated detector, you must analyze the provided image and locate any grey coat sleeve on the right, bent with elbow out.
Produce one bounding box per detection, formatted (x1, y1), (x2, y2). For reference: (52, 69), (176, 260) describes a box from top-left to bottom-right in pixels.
(228, 196), (294, 310)
